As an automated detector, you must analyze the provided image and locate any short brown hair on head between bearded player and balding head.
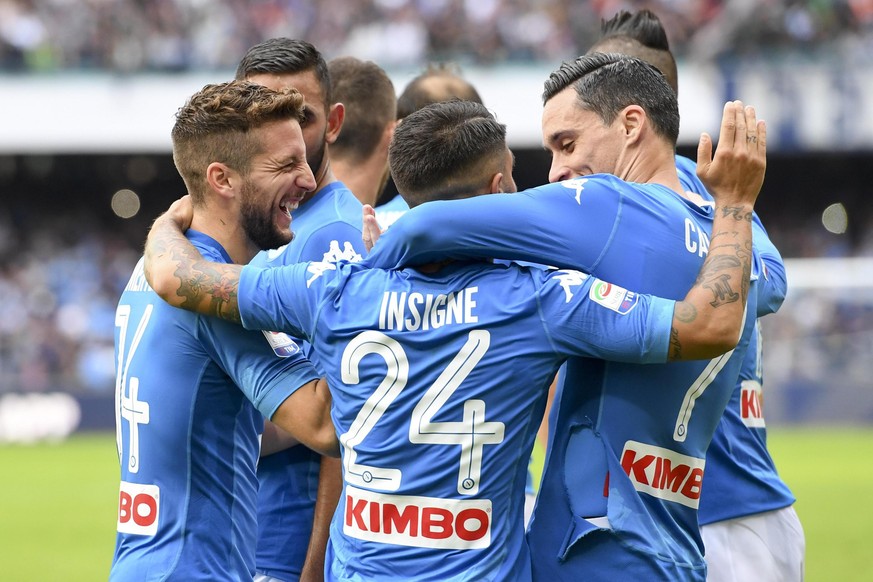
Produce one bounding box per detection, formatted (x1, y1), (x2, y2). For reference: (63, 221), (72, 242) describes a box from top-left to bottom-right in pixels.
(327, 57), (397, 162)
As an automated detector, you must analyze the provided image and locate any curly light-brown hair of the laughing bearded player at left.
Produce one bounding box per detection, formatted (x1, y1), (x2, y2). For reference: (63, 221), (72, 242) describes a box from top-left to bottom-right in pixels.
(171, 81), (304, 203)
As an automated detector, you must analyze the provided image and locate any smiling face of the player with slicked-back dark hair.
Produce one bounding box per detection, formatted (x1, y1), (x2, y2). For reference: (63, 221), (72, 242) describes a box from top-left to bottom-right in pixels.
(542, 86), (623, 182)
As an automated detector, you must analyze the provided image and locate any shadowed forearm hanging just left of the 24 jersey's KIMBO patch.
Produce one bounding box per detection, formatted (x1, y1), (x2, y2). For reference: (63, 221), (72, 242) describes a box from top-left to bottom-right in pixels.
(300, 457), (343, 582)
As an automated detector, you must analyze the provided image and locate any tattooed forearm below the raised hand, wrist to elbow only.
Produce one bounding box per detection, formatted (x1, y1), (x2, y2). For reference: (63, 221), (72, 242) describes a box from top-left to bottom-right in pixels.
(669, 204), (752, 360)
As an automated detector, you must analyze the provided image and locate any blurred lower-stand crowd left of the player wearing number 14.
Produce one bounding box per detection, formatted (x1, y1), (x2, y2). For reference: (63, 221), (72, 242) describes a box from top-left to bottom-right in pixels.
(0, 216), (140, 393)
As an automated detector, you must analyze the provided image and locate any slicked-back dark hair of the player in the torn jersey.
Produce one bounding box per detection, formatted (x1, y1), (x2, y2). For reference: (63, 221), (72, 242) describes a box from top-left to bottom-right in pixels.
(543, 53), (679, 146)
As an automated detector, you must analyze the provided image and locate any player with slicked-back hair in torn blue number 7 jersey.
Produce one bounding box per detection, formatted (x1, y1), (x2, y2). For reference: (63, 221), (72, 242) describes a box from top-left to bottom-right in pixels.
(367, 54), (761, 580)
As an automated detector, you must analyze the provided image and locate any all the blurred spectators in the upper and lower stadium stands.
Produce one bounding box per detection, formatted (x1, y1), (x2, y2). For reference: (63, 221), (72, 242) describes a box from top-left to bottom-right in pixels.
(0, 0), (873, 419)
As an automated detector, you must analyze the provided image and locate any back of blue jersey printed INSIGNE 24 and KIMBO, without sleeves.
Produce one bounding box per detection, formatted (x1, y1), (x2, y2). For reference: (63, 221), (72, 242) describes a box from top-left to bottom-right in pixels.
(315, 265), (559, 580)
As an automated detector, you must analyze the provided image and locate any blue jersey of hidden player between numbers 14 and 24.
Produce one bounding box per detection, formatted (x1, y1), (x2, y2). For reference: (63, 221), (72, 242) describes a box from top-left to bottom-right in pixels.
(251, 182), (366, 582)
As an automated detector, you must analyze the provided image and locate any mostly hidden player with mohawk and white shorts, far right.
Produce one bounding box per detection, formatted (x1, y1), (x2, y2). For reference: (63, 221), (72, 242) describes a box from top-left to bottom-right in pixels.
(589, 10), (806, 582)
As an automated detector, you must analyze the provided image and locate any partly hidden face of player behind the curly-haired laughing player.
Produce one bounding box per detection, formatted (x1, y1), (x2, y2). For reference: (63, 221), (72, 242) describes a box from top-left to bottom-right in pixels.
(248, 71), (328, 192)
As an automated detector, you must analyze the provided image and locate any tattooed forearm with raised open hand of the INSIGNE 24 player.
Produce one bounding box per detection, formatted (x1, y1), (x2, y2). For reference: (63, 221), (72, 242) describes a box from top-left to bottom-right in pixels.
(669, 101), (767, 360)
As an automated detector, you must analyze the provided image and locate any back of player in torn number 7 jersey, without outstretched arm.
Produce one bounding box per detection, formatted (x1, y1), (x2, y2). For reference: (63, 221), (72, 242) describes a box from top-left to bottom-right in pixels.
(529, 175), (755, 580)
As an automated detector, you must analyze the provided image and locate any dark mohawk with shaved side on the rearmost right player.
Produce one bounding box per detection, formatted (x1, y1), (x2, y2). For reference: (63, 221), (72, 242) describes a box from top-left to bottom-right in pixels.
(588, 10), (679, 92)
